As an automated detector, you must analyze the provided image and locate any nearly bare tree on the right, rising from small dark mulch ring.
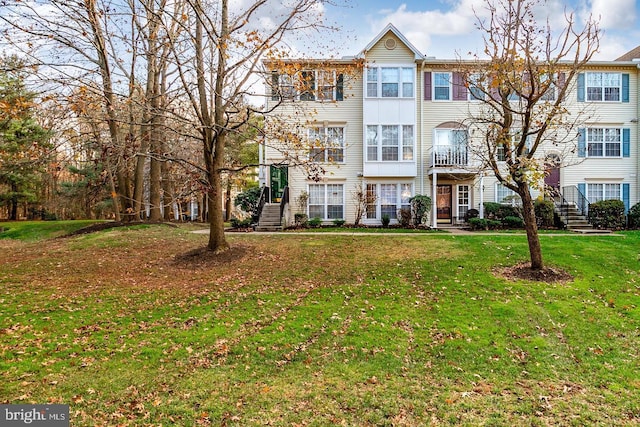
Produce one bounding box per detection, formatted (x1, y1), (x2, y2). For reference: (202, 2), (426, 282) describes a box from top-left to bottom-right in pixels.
(461, 0), (599, 270)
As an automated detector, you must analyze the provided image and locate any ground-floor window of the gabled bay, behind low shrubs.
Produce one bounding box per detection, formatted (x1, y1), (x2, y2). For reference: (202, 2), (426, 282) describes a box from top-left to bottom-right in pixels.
(367, 183), (413, 219)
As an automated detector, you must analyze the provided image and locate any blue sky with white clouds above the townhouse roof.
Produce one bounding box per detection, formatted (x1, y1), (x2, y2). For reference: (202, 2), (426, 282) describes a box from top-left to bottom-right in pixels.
(326, 0), (640, 60)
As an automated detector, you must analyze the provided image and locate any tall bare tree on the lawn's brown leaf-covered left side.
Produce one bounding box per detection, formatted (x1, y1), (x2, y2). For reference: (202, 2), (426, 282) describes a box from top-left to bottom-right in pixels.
(161, 0), (350, 252)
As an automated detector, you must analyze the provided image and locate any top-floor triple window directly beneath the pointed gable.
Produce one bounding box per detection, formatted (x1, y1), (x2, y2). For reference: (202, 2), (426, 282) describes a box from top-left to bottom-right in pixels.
(367, 67), (415, 98)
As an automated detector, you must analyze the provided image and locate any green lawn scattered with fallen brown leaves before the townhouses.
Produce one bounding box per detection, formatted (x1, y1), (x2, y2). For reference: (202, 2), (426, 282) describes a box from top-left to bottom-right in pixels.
(0, 223), (640, 426)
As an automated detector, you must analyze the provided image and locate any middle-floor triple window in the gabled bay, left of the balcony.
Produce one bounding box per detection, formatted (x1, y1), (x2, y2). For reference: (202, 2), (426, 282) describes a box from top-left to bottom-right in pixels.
(366, 125), (415, 162)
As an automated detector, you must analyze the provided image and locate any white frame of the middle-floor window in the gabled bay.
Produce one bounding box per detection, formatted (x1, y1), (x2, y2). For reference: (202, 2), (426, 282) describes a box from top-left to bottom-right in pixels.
(365, 124), (416, 163)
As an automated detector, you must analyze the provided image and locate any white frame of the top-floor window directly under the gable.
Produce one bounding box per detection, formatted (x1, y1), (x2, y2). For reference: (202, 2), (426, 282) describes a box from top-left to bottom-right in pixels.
(365, 65), (416, 99)
